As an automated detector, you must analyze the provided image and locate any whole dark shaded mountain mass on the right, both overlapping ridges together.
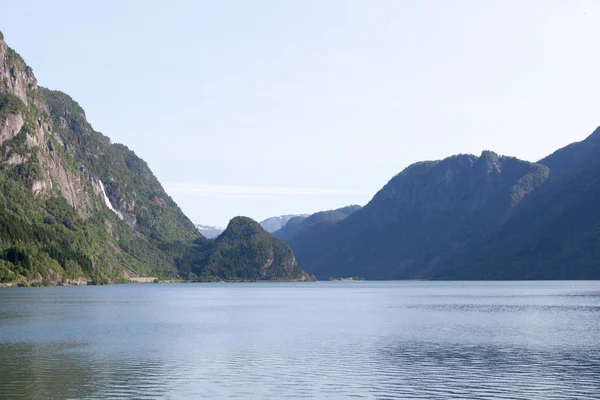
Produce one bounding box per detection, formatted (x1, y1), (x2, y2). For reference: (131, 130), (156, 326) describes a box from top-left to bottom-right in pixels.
(289, 134), (600, 279)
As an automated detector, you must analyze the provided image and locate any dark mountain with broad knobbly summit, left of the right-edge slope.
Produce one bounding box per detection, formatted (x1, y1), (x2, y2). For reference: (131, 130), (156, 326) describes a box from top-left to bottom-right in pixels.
(289, 151), (549, 279)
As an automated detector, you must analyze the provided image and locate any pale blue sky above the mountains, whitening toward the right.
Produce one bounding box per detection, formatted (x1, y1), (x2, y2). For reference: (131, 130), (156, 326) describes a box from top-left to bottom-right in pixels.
(0, 0), (600, 226)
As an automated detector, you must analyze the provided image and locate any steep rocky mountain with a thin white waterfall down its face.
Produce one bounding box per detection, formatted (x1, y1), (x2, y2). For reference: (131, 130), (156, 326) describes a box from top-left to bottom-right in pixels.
(0, 33), (310, 284)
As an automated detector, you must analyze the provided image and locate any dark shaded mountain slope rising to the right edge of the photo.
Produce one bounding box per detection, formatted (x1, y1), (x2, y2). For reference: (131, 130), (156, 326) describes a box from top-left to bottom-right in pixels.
(436, 128), (600, 279)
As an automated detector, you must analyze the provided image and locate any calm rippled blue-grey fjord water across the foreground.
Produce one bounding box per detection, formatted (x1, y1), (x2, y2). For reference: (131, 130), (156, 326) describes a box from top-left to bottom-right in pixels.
(0, 282), (600, 399)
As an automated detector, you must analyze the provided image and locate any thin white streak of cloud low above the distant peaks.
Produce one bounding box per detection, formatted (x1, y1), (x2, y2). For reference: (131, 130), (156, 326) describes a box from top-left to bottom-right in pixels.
(165, 182), (368, 197)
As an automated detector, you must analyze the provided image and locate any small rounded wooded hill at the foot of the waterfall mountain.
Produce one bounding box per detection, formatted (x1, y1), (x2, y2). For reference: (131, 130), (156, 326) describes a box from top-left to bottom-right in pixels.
(179, 217), (309, 281)
